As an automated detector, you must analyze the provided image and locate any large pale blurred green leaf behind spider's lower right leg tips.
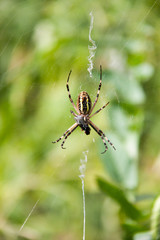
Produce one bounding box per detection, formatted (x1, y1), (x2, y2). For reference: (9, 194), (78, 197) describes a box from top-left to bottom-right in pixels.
(101, 131), (138, 190)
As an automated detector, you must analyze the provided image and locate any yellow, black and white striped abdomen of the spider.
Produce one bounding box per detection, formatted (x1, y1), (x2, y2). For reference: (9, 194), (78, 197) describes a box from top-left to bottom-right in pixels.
(77, 92), (92, 115)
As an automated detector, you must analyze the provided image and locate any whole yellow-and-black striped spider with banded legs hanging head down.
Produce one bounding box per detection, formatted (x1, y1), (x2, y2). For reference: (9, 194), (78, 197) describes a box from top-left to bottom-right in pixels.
(52, 65), (116, 153)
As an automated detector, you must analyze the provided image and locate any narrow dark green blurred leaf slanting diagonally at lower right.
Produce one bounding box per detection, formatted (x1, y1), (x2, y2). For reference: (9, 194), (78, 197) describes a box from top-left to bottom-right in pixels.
(97, 178), (142, 220)
